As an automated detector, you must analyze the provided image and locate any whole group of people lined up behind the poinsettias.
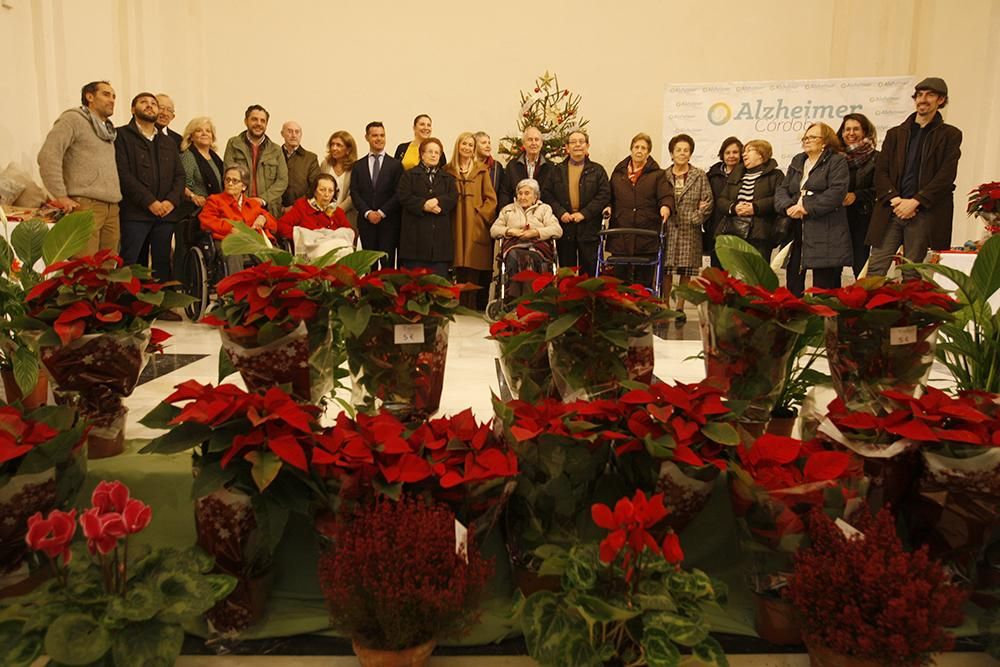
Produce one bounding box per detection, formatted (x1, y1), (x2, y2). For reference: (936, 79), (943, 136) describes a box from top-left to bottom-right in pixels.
(38, 77), (962, 312)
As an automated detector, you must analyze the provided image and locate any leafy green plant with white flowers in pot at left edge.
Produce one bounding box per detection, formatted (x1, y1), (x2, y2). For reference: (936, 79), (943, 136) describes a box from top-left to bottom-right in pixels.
(0, 211), (94, 407)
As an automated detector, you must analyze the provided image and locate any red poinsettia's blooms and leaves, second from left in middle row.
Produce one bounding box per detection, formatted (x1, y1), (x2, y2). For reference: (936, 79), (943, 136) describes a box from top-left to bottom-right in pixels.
(140, 380), (321, 554)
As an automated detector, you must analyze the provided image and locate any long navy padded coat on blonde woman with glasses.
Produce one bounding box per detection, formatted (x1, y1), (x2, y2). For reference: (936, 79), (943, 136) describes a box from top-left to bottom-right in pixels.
(774, 148), (854, 269)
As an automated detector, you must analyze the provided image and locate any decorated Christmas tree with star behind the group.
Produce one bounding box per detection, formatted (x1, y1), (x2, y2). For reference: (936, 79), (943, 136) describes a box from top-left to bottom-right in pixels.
(497, 70), (587, 162)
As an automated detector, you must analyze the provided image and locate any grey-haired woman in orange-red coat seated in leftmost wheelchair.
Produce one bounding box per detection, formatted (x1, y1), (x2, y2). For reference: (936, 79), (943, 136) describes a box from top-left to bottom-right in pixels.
(198, 164), (278, 273)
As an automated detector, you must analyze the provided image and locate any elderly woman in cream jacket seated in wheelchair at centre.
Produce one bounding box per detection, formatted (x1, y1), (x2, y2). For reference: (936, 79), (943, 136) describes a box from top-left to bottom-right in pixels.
(490, 178), (562, 298)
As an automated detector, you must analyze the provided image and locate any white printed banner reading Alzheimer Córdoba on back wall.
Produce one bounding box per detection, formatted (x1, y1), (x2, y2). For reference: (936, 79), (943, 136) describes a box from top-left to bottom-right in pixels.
(660, 76), (917, 170)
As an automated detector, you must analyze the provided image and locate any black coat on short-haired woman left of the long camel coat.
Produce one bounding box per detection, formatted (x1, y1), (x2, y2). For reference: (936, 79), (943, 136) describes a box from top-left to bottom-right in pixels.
(398, 163), (458, 262)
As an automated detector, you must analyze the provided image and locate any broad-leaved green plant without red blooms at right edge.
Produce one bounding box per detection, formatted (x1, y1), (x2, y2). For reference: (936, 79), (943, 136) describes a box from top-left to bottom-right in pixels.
(906, 238), (1000, 394)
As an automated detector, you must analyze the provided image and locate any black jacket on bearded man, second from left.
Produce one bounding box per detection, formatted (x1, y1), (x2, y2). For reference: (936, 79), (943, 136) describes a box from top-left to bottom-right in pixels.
(115, 119), (184, 222)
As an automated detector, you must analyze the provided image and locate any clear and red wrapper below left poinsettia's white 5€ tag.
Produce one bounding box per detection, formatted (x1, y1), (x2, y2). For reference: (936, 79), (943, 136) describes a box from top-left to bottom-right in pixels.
(345, 314), (448, 421)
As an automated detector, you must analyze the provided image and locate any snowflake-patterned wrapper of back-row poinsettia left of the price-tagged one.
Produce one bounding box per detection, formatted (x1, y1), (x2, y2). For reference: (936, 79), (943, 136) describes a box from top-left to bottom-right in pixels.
(219, 310), (339, 403)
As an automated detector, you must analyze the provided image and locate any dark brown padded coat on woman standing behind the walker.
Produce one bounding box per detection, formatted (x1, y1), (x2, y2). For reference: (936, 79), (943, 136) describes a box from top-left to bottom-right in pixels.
(608, 156), (676, 255)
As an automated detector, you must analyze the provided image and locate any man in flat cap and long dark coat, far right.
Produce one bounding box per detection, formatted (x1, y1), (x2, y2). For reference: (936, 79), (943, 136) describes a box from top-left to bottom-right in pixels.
(865, 76), (962, 276)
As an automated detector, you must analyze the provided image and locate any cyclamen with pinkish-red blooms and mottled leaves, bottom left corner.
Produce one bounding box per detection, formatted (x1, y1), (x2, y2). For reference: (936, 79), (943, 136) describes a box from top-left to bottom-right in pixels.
(0, 482), (235, 667)
